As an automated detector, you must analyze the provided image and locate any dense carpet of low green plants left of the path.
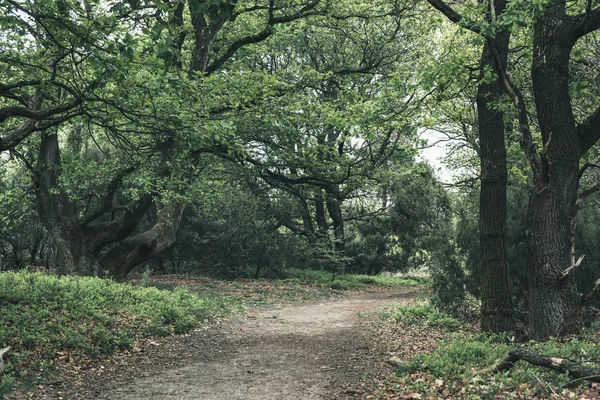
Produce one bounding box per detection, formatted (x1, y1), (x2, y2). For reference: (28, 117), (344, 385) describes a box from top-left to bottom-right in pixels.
(0, 272), (234, 393)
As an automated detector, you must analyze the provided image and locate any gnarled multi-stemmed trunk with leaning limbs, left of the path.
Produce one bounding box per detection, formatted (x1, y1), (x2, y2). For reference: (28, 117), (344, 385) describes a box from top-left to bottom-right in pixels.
(36, 130), (185, 279)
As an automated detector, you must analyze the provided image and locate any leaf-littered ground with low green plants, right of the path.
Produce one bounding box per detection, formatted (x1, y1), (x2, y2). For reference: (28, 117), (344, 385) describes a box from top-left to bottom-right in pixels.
(363, 302), (600, 399)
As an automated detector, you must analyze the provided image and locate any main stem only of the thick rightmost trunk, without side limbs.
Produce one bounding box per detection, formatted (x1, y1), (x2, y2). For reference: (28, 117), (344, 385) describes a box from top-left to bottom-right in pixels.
(528, 2), (580, 339)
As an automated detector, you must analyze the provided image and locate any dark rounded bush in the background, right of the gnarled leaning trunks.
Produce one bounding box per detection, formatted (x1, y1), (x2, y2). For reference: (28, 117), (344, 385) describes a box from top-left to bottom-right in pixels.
(170, 170), (307, 279)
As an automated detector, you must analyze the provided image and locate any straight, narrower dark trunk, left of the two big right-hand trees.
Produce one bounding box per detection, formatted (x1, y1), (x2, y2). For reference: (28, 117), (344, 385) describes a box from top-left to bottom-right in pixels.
(477, 0), (514, 332)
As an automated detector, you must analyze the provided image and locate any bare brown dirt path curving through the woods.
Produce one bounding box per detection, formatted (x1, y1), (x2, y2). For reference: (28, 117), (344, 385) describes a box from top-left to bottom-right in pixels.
(22, 289), (417, 400)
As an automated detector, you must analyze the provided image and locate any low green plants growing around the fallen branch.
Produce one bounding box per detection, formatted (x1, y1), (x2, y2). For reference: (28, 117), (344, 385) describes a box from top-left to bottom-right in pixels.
(396, 333), (600, 398)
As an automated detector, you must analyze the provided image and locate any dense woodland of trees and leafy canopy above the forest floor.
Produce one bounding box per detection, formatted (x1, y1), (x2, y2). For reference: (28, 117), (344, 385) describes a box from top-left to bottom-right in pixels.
(0, 0), (600, 374)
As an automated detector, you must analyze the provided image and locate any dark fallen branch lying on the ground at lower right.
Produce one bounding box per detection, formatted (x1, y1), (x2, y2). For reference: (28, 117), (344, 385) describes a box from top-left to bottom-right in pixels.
(476, 349), (600, 382)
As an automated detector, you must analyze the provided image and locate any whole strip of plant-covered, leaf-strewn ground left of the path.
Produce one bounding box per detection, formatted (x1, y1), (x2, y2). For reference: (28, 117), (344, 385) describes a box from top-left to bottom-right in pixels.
(0, 270), (427, 394)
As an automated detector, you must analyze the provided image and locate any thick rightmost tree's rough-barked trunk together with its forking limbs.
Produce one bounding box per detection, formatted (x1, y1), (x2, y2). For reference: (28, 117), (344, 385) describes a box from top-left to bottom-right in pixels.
(428, 0), (600, 339)
